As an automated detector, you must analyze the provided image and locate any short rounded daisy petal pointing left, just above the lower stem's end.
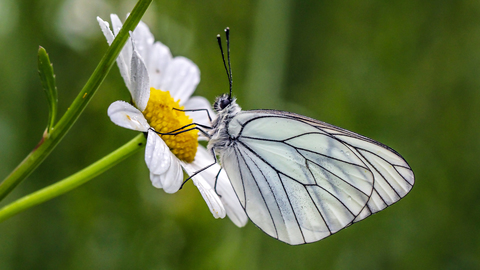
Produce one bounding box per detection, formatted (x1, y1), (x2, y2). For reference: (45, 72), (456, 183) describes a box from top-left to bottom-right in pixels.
(107, 101), (150, 132)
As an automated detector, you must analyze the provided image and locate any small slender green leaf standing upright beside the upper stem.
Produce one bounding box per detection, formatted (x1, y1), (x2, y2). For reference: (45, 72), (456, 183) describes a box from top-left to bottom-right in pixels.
(38, 47), (58, 134)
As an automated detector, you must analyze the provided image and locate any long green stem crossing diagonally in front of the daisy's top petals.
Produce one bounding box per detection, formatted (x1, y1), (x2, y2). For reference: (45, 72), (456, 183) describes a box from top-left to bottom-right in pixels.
(0, 0), (152, 201)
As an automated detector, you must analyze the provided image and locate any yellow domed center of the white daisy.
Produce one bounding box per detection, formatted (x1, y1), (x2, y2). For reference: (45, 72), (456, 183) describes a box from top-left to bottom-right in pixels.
(143, 87), (198, 162)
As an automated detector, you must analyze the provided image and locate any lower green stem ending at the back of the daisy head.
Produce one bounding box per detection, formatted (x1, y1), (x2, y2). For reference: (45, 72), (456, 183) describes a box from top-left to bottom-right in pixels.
(0, 134), (145, 222)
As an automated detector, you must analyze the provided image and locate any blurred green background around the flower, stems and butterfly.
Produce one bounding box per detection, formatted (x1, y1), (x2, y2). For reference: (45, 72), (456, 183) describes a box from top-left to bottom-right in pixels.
(0, 0), (480, 270)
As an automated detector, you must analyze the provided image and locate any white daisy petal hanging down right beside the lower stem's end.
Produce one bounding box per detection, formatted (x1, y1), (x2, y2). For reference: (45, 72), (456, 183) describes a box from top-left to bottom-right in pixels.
(145, 129), (172, 175)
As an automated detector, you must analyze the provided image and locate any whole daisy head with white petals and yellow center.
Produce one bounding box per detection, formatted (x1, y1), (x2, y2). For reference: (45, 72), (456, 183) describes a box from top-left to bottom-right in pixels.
(97, 14), (247, 227)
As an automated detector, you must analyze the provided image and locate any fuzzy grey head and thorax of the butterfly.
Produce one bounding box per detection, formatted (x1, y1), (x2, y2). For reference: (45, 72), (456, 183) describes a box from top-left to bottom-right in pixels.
(208, 95), (242, 154)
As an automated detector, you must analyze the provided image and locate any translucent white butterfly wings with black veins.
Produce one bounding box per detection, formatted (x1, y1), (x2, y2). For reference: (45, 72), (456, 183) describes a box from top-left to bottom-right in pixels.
(220, 110), (414, 245)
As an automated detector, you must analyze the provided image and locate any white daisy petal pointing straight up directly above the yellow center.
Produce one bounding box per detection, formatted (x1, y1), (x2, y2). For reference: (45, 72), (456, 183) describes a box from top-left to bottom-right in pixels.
(147, 41), (172, 90)
